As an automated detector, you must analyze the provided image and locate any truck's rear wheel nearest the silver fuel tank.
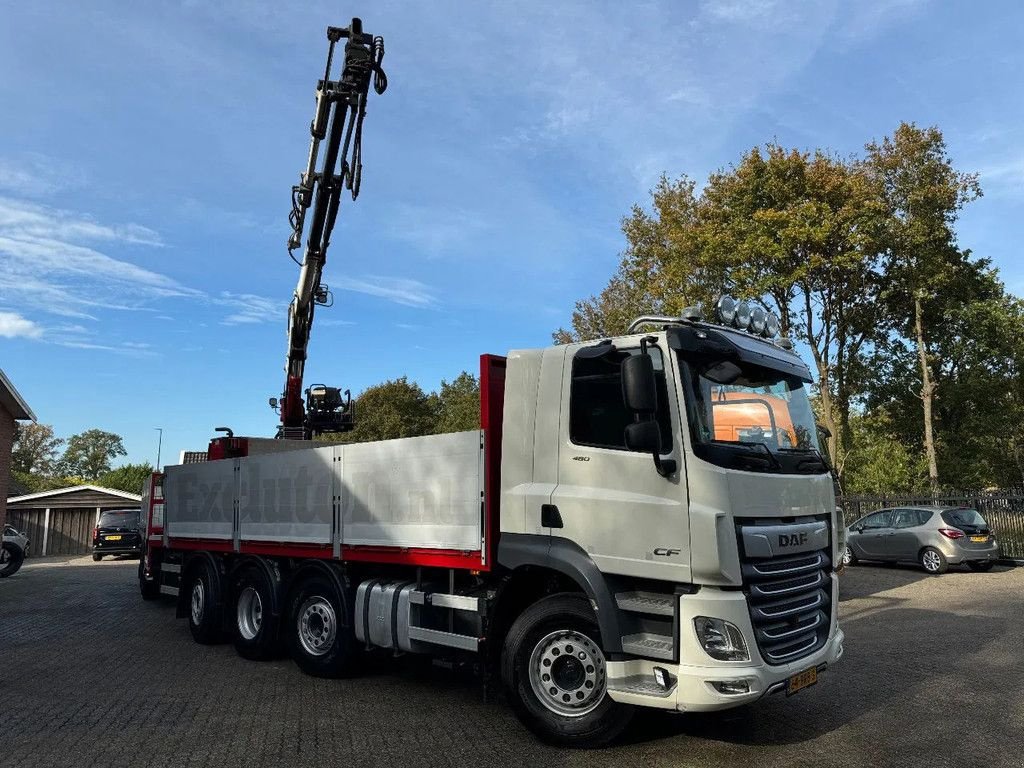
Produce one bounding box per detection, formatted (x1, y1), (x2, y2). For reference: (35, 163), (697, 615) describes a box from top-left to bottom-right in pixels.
(285, 573), (359, 678)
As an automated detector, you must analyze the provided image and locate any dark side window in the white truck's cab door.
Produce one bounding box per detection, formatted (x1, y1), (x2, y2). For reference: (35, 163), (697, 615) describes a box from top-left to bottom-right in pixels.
(569, 347), (672, 454)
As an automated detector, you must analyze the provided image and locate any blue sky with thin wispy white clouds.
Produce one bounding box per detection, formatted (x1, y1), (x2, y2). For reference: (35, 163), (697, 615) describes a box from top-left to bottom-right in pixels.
(0, 0), (1024, 462)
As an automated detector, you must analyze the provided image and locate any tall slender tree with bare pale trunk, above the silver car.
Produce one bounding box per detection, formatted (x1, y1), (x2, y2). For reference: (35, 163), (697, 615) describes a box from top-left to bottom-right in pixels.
(865, 123), (981, 490)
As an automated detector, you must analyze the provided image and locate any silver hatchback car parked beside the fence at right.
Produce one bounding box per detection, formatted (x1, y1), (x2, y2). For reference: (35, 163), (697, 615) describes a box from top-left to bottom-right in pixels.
(843, 507), (999, 573)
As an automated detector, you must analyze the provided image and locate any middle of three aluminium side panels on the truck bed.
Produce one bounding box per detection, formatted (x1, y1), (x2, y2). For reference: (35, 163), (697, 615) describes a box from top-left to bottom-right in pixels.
(239, 446), (335, 544)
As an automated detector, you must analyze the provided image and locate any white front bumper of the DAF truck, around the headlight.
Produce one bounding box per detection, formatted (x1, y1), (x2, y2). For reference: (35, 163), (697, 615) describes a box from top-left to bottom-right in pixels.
(607, 584), (845, 712)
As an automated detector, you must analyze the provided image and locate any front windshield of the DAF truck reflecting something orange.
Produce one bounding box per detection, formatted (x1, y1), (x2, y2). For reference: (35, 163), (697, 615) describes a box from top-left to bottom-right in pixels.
(681, 355), (828, 473)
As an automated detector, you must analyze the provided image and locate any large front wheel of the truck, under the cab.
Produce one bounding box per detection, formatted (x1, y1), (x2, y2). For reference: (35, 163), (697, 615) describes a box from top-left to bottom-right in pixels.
(502, 593), (633, 748)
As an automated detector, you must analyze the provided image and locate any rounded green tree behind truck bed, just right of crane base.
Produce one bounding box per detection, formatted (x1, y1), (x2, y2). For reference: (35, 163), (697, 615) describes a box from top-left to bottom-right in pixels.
(333, 376), (437, 442)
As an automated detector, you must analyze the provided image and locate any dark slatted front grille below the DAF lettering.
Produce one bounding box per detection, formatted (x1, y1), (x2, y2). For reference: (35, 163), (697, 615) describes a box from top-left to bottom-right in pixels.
(737, 524), (831, 665)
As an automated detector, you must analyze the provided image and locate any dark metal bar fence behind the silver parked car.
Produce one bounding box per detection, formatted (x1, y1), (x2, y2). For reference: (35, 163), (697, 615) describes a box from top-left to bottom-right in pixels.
(839, 488), (1024, 560)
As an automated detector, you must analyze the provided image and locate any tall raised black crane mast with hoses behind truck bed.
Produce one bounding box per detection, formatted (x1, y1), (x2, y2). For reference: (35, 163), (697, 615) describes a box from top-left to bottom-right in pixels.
(270, 18), (387, 439)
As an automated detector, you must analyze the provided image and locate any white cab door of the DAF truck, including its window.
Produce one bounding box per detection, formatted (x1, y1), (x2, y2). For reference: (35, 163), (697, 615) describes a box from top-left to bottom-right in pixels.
(546, 337), (690, 582)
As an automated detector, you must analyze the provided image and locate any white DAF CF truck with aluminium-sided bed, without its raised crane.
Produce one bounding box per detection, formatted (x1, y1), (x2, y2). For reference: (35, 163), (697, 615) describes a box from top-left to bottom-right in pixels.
(139, 299), (843, 746)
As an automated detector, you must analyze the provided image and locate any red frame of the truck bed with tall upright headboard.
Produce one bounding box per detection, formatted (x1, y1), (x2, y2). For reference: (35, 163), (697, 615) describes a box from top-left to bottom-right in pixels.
(148, 354), (506, 571)
